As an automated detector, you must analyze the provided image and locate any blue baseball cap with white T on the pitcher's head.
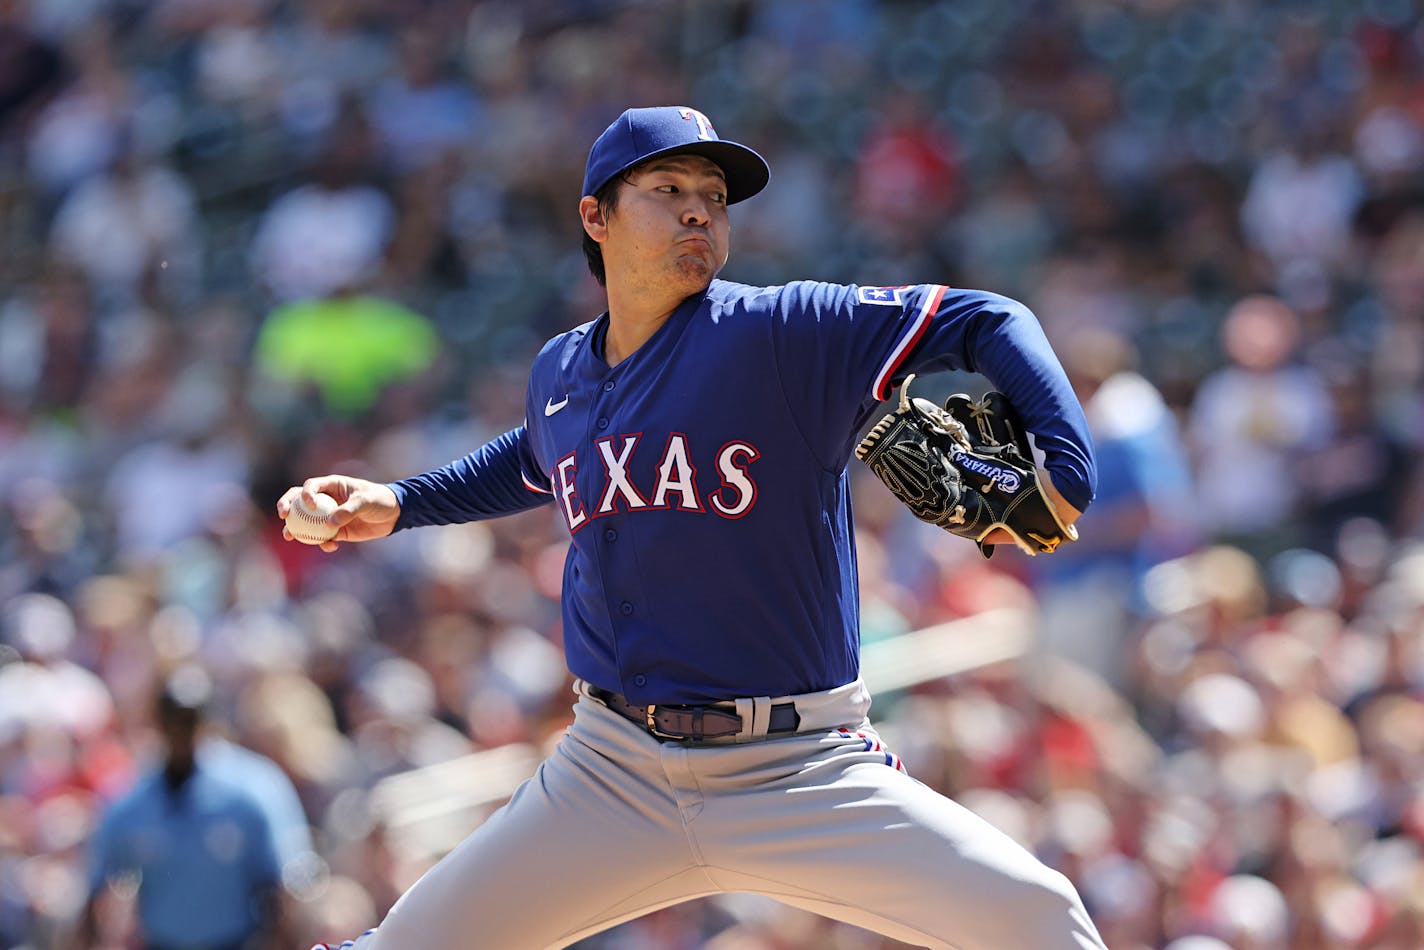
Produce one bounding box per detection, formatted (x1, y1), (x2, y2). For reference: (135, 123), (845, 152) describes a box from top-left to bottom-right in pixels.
(584, 105), (772, 205)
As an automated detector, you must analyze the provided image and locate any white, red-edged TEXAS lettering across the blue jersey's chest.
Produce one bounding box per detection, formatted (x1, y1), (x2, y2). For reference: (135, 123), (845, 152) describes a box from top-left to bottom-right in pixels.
(550, 432), (762, 534)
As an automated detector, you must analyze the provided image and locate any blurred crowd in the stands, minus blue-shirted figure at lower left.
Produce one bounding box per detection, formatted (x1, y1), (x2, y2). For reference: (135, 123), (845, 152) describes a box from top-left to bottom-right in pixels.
(0, 0), (1424, 950)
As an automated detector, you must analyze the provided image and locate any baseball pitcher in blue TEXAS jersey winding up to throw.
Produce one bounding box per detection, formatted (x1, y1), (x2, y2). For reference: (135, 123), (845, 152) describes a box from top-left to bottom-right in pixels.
(289, 107), (1104, 950)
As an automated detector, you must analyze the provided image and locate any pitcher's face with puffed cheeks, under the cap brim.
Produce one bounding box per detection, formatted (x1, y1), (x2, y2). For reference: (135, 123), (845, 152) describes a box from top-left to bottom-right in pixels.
(602, 155), (732, 299)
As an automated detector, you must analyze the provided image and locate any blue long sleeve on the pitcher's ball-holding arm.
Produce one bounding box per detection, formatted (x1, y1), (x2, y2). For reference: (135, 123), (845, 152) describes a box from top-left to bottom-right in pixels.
(390, 426), (553, 531)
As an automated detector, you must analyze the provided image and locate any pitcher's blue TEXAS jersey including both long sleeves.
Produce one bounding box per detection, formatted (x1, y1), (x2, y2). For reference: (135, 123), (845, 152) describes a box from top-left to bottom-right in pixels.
(392, 281), (1095, 704)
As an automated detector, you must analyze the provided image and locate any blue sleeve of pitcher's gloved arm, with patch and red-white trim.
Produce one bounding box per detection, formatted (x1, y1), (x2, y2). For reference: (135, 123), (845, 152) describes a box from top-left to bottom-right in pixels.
(773, 282), (1096, 511)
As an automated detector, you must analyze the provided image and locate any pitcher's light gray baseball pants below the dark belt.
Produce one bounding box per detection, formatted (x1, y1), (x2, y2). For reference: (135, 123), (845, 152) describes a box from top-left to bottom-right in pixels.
(357, 682), (1105, 950)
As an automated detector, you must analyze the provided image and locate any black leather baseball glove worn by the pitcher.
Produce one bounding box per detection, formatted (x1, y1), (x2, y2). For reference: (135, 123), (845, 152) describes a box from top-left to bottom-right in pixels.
(856, 376), (1078, 557)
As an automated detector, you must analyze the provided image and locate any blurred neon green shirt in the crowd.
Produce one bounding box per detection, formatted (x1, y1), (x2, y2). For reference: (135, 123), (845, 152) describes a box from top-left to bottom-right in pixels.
(256, 293), (439, 414)
